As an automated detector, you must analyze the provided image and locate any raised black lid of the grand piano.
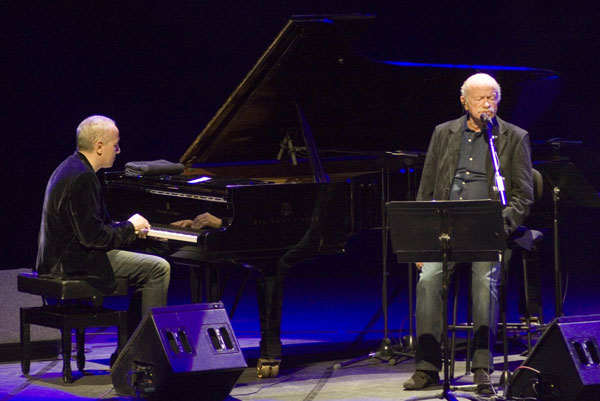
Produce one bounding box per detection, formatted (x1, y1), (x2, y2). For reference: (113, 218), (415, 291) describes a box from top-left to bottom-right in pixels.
(180, 14), (558, 167)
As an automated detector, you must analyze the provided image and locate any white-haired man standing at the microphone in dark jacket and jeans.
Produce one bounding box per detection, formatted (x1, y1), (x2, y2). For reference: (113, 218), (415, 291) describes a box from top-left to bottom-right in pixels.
(404, 73), (533, 393)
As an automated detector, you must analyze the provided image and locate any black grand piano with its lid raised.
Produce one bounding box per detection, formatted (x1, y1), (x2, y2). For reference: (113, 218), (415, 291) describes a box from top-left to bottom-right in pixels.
(105, 15), (553, 376)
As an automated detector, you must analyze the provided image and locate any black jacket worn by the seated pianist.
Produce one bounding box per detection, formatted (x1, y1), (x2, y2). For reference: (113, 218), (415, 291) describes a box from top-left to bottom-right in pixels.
(36, 152), (135, 294)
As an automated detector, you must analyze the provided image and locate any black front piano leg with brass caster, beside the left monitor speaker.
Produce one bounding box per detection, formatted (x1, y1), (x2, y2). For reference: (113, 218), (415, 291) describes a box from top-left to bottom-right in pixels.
(256, 262), (284, 378)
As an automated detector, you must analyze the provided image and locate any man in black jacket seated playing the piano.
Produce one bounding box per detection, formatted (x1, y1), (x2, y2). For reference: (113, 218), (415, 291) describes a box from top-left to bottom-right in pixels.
(36, 116), (171, 334)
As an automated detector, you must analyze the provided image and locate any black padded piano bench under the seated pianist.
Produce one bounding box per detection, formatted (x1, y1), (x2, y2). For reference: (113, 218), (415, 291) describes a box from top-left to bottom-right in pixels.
(17, 272), (127, 383)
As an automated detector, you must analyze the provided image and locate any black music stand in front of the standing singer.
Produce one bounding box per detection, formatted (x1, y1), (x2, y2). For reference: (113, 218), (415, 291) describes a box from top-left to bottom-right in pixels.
(386, 200), (506, 400)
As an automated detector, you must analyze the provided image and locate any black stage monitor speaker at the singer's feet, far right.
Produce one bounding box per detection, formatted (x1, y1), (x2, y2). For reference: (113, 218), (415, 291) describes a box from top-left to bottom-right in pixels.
(507, 315), (600, 401)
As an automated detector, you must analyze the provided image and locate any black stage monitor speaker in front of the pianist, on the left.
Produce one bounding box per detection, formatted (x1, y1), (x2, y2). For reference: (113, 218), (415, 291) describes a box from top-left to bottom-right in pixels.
(110, 302), (247, 401)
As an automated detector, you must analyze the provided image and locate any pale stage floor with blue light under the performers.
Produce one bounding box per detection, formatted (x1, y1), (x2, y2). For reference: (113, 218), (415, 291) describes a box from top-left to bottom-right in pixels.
(0, 329), (524, 401)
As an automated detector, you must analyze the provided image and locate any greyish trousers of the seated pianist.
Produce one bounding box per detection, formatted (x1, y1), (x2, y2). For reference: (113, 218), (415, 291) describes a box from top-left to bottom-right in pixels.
(107, 249), (171, 337)
